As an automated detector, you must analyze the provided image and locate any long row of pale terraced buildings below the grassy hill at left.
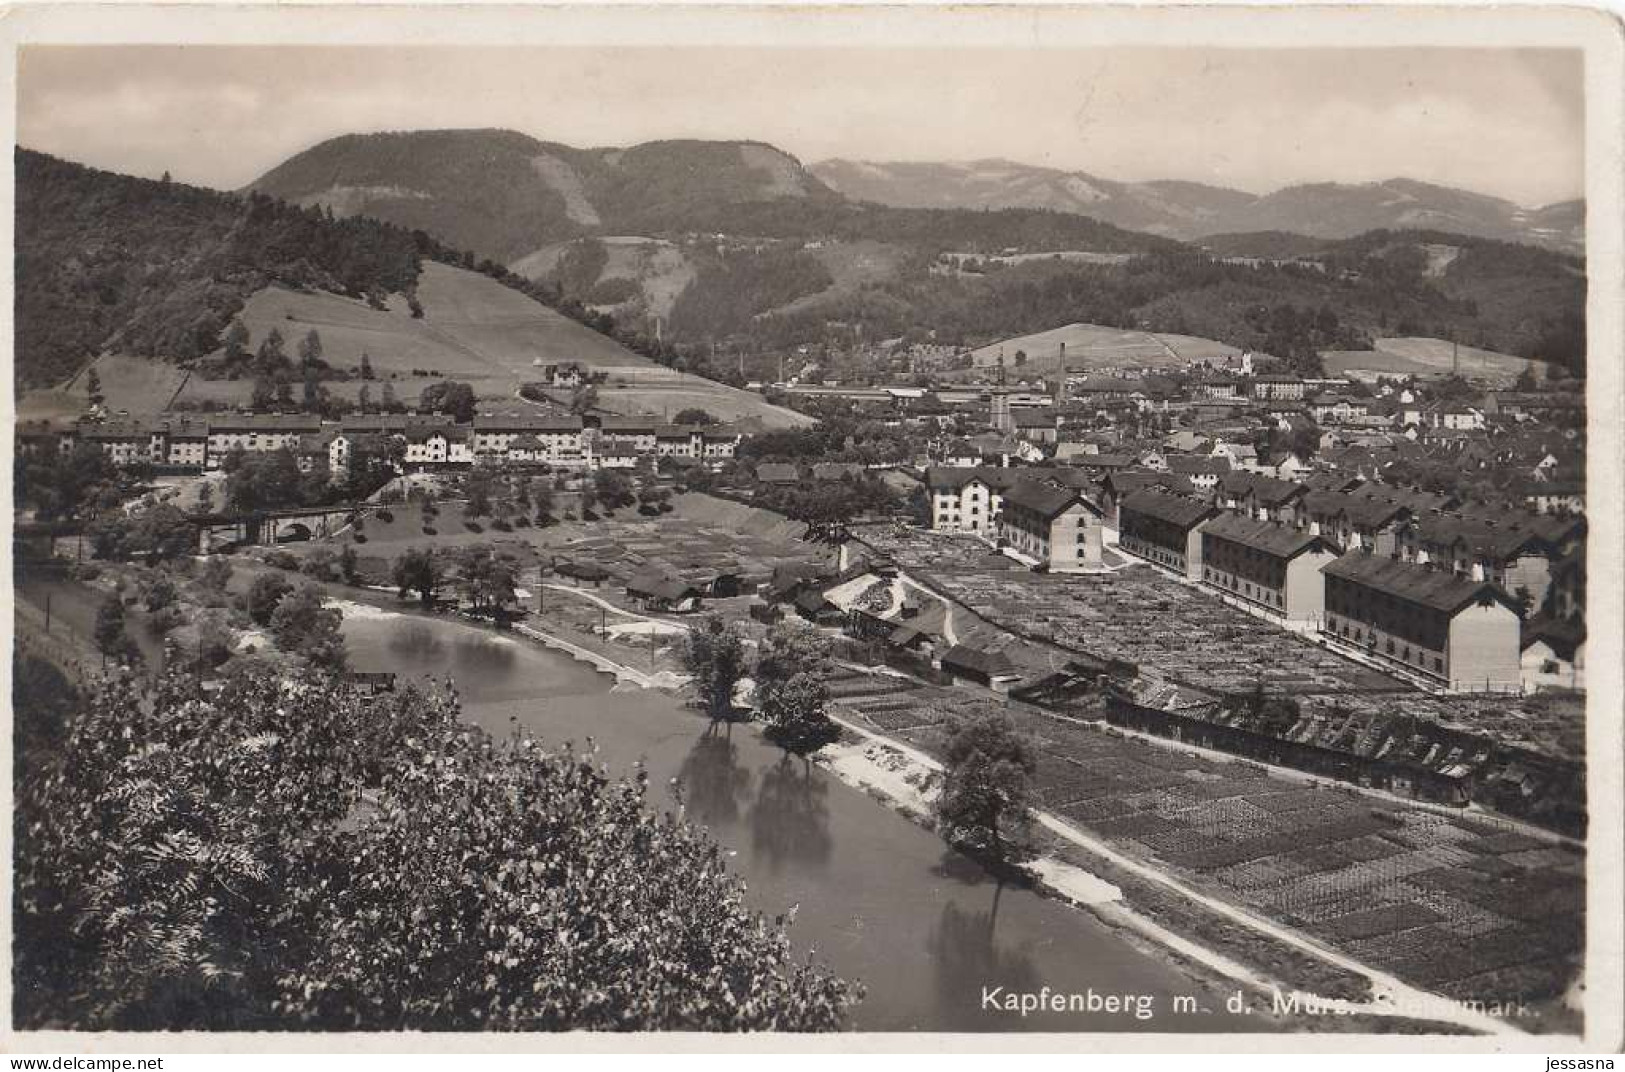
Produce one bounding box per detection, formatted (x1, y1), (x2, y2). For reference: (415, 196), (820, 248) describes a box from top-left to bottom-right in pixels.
(16, 413), (741, 474)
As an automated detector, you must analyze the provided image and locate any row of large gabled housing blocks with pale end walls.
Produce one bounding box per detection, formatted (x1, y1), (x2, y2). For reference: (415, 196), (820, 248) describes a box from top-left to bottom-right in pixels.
(928, 468), (1584, 690)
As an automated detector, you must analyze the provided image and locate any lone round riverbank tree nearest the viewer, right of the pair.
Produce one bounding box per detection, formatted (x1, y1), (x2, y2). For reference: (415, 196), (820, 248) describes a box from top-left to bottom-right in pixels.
(934, 715), (1038, 864)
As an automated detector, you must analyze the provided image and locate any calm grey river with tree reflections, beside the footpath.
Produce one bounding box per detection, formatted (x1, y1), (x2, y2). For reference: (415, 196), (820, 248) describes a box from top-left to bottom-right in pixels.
(345, 611), (1255, 1031)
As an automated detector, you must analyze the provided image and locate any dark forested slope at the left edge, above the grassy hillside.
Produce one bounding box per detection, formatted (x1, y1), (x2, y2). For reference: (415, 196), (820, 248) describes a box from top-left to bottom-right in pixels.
(15, 148), (419, 390)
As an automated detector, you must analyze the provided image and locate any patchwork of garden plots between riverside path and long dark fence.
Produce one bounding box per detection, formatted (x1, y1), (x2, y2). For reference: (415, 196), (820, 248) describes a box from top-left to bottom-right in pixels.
(819, 674), (1584, 1020)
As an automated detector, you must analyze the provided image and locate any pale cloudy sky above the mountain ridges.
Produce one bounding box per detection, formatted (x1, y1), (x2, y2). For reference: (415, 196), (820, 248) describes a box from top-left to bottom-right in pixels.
(18, 45), (1584, 206)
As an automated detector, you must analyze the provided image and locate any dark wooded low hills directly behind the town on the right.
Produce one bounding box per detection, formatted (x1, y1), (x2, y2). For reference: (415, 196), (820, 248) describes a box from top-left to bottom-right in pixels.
(744, 232), (1586, 375)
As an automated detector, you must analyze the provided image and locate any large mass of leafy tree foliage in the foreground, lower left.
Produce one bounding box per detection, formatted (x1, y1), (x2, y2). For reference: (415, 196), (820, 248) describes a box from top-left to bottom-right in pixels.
(13, 664), (861, 1031)
